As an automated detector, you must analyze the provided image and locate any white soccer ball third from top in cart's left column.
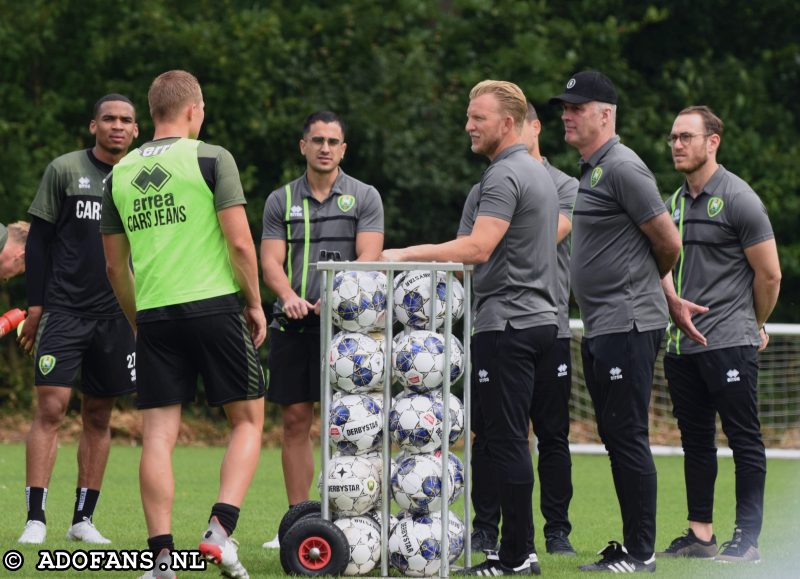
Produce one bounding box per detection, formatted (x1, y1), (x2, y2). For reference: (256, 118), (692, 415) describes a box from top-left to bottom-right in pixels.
(328, 394), (383, 454)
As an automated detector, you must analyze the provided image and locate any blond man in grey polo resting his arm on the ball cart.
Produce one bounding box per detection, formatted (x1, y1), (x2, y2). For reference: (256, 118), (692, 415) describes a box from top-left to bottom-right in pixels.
(382, 80), (558, 576)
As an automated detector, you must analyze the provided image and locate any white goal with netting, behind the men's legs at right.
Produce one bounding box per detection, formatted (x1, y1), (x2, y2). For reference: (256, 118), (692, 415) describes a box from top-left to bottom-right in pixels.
(570, 319), (800, 458)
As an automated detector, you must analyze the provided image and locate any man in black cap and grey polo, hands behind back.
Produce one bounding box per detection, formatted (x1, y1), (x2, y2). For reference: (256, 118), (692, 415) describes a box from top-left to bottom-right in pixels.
(550, 71), (681, 572)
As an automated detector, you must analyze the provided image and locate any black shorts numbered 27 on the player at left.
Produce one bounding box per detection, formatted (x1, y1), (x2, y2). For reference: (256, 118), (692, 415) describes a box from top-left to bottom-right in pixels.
(34, 311), (136, 397)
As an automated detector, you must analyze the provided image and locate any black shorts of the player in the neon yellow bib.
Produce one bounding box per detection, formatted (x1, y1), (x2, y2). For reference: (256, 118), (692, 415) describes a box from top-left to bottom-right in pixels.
(136, 313), (264, 408)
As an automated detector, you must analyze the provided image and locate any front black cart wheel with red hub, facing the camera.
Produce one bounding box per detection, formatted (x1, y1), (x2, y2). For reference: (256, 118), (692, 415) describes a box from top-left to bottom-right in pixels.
(281, 518), (350, 576)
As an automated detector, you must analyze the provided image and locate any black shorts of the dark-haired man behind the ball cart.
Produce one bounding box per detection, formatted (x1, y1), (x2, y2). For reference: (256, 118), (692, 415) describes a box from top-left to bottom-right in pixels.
(267, 330), (321, 406)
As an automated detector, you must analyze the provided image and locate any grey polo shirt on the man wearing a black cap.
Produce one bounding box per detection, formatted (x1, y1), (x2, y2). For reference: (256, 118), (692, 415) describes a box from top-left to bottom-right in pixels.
(570, 136), (668, 338)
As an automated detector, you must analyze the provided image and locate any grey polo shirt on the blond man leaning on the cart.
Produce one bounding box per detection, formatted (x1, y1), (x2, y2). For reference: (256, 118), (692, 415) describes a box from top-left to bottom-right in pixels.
(458, 145), (558, 332)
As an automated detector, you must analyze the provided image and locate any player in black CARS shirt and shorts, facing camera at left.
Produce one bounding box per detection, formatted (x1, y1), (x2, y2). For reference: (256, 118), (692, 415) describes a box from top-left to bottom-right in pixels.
(18, 94), (139, 544)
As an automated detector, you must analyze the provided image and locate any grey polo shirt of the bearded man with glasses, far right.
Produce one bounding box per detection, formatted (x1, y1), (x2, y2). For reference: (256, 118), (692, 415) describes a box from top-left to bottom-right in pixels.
(666, 165), (775, 354)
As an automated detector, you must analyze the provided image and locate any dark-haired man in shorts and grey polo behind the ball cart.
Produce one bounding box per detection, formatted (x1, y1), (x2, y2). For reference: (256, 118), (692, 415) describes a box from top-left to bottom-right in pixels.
(261, 111), (383, 548)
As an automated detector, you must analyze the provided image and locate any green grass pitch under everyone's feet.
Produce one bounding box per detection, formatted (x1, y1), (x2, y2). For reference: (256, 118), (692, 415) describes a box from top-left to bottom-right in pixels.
(0, 444), (800, 579)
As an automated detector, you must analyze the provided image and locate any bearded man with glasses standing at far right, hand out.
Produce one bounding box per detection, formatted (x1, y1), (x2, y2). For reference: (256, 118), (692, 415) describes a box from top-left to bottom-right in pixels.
(658, 106), (781, 562)
